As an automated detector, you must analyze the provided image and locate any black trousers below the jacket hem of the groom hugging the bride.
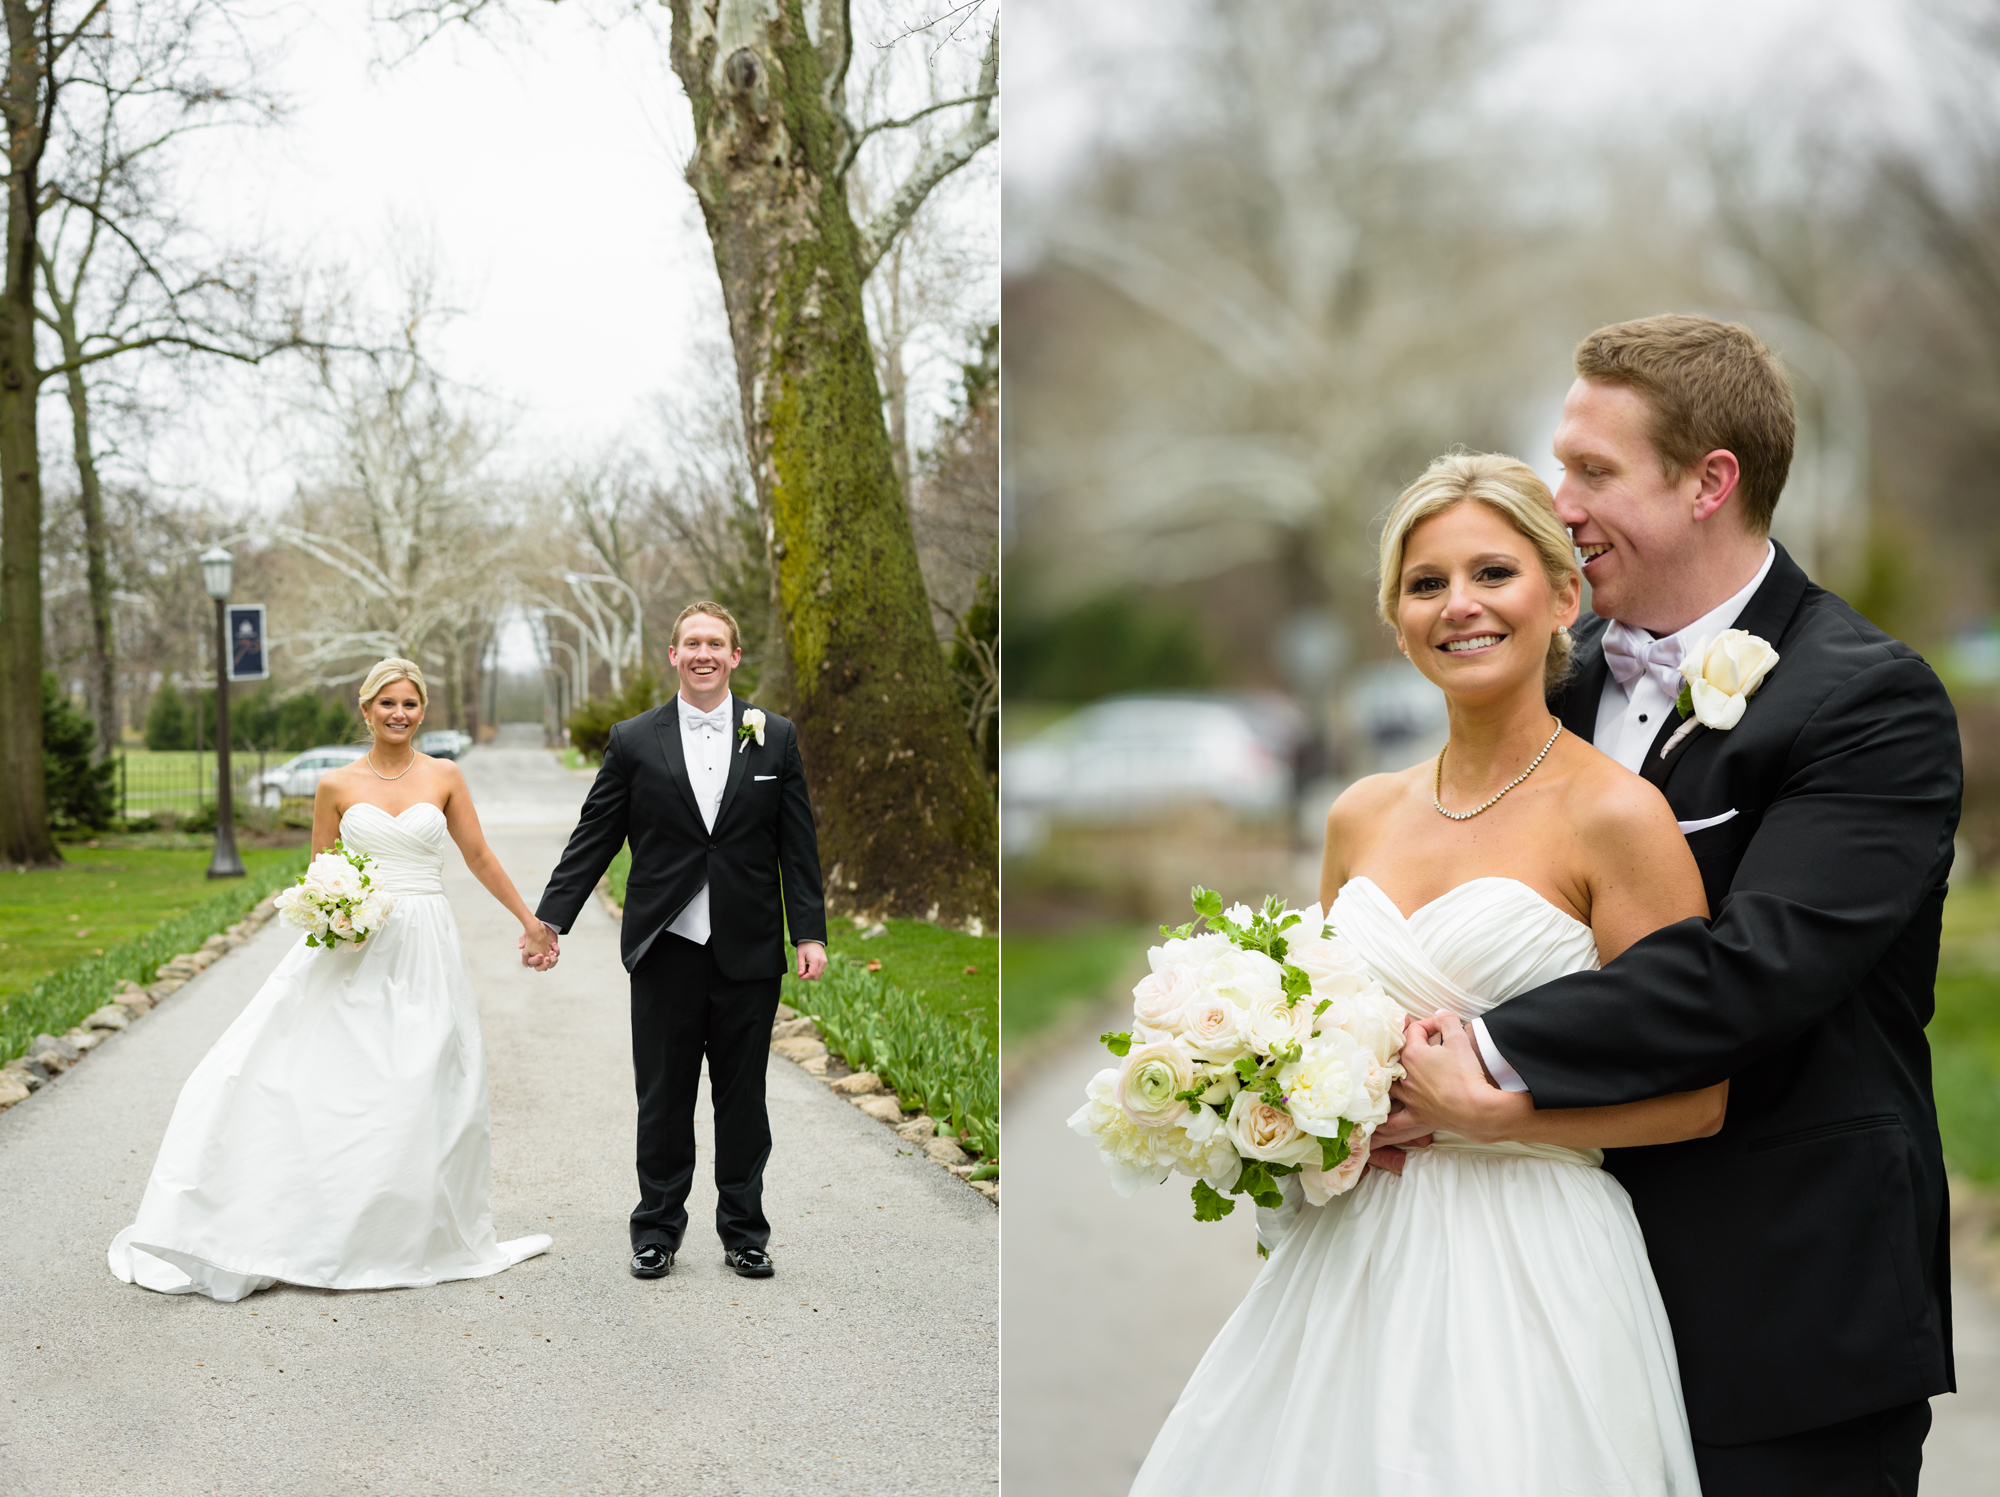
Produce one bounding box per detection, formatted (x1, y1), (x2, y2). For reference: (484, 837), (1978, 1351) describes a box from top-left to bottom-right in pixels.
(1694, 1401), (1930, 1497)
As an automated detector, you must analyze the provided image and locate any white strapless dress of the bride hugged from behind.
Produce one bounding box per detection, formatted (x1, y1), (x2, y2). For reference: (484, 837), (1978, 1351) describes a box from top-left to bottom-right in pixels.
(1132, 879), (1700, 1497)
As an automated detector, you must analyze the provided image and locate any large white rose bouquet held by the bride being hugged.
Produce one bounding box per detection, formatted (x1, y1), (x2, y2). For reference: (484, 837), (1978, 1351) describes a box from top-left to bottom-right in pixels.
(1070, 887), (1402, 1221)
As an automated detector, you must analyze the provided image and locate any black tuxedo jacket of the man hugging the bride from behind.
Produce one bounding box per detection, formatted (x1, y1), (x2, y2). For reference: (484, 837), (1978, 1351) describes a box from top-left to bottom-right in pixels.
(1486, 548), (1960, 1445)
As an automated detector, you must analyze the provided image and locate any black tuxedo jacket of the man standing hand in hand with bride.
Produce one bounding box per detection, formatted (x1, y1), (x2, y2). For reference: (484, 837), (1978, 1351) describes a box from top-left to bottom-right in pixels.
(536, 696), (826, 981)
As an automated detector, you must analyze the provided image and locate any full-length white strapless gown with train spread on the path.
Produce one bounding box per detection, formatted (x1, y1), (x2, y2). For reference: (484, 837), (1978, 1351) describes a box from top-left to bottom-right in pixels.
(110, 803), (550, 1299)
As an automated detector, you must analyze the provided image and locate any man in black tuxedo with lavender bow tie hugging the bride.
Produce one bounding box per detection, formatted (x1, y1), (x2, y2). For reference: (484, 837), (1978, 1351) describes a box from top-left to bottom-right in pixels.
(1384, 316), (1962, 1497)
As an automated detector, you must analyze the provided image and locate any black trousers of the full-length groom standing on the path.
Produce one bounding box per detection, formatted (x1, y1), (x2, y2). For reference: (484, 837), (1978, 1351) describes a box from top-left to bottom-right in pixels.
(632, 931), (782, 1251)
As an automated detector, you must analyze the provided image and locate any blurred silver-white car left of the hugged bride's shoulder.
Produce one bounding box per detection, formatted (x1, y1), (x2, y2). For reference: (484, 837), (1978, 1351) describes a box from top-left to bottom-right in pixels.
(1000, 692), (1298, 847)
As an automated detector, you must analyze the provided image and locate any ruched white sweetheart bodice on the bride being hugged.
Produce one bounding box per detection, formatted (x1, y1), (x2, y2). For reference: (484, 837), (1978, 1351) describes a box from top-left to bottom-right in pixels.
(1328, 877), (1604, 1165)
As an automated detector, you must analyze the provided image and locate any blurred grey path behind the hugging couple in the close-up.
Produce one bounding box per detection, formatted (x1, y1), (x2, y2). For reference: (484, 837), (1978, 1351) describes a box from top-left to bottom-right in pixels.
(1002, 1013), (2000, 1497)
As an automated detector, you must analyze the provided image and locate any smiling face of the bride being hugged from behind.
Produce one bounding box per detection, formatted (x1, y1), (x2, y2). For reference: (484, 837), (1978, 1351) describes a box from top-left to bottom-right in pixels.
(1396, 500), (1580, 694)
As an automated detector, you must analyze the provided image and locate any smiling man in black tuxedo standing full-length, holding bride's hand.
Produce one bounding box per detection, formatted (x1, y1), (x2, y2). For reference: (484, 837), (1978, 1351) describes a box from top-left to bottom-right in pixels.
(536, 602), (826, 1279)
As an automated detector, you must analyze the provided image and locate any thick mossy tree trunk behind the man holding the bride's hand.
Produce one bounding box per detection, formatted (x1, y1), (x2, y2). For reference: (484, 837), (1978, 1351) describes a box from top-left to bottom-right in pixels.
(672, 0), (998, 923)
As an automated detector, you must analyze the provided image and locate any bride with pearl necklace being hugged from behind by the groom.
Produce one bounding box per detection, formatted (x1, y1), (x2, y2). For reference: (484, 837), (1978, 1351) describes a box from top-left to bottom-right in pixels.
(1132, 456), (1728, 1497)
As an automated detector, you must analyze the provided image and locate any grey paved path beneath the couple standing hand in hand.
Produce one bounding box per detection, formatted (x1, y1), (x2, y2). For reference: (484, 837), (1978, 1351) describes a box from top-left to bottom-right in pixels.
(0, 746), (998, 1497)
